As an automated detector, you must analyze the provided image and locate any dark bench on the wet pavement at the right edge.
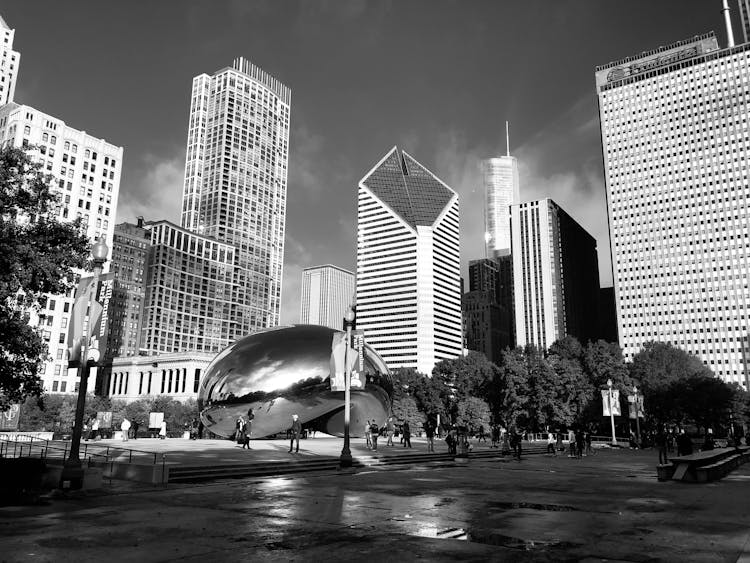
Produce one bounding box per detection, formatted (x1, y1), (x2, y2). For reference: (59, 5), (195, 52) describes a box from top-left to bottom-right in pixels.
(657, 446), (750, 483)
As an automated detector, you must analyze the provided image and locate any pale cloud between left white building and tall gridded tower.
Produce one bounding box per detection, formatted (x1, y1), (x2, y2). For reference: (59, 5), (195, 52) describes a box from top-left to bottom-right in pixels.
(117, 154), (185, 224)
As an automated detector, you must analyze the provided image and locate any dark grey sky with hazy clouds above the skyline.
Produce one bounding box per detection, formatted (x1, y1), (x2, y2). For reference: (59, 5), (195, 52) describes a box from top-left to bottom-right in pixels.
(0, 0), (741, 323)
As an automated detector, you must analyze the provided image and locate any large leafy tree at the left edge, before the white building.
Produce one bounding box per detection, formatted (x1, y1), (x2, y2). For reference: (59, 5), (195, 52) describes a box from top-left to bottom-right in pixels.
(0, 147), (89, 410)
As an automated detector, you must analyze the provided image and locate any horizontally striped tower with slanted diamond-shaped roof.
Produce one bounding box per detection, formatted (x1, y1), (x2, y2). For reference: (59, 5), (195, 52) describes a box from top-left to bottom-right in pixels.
(357, 147), (462, 374)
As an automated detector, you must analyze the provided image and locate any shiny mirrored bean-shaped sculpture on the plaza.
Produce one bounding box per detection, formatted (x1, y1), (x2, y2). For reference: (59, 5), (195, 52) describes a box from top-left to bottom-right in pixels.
(198, 325), (393, 438)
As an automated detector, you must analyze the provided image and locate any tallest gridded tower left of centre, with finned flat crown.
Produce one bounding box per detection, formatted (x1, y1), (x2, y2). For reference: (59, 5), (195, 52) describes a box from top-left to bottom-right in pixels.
(181, 58), (291, 341)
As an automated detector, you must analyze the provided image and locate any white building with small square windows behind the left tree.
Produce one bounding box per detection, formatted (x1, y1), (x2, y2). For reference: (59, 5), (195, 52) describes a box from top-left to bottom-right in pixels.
(0, 102), (123, 393)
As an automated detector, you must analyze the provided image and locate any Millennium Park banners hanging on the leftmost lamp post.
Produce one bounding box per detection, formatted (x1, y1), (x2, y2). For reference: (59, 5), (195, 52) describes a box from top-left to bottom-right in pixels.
(68, 273), (115, 368)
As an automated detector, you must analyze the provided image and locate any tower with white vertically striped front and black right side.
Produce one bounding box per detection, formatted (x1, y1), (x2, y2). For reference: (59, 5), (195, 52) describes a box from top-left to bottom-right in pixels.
(511, 198), (599, 349)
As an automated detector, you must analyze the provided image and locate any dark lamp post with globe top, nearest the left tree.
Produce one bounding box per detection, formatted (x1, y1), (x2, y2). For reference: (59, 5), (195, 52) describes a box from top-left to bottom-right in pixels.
(61, 235), (109, 489)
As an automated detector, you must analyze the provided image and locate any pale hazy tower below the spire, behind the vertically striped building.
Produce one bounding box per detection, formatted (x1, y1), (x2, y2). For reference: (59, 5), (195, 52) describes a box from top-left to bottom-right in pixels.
(482, 155), (520, 258)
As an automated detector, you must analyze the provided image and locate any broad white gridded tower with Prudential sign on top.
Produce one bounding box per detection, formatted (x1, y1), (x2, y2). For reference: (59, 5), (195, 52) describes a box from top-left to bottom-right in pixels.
(595, 29), (750, 387)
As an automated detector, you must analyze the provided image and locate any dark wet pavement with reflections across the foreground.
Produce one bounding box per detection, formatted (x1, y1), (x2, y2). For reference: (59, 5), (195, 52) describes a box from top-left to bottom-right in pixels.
(0, 450), (750, 562)
